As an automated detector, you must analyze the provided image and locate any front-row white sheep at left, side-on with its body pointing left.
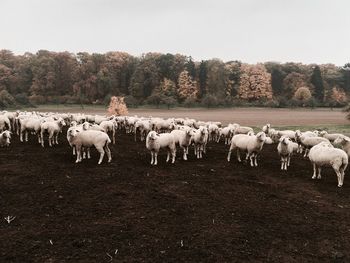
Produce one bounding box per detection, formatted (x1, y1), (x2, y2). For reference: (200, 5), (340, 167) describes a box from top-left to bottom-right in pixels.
(67, 127), (112, 164)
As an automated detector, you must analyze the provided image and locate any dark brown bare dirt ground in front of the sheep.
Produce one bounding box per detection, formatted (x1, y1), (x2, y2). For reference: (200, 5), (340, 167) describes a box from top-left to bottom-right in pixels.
(0, 128), (350, 263)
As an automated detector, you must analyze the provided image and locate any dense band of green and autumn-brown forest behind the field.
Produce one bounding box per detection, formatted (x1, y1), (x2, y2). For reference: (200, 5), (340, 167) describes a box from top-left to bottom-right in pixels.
(0, 50), (350, 108)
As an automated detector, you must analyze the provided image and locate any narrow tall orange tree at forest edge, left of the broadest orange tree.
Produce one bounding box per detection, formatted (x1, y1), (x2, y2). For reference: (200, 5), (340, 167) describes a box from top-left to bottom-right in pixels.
(177, 70), (198, 101)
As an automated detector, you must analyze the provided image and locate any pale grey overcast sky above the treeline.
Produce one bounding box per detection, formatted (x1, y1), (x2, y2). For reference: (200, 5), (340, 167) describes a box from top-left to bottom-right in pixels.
(0, 0), (350, 65)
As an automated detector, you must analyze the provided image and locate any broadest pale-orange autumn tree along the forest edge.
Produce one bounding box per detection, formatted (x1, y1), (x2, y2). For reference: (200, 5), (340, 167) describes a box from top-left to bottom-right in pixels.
(238, 64), (272, 101)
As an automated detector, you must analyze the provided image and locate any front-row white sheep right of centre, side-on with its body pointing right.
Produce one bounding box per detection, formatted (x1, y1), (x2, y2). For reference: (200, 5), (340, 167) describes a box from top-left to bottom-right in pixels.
(227, 132), (266, 166)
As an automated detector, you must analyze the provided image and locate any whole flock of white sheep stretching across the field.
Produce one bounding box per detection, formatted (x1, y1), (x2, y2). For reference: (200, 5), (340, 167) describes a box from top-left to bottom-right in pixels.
(0, 111), (350, 187)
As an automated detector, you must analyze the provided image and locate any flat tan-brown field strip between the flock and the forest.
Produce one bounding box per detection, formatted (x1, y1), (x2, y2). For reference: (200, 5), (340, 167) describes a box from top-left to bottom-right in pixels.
(23, 105), (350, 134)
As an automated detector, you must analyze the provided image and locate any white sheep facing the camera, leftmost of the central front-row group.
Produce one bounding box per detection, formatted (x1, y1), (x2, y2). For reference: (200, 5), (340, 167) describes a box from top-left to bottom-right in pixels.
(146, 131), (176, 165)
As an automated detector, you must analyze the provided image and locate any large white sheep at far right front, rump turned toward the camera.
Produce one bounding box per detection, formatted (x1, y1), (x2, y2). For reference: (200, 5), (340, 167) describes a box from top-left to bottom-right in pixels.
(309, 142), (348, 187)
